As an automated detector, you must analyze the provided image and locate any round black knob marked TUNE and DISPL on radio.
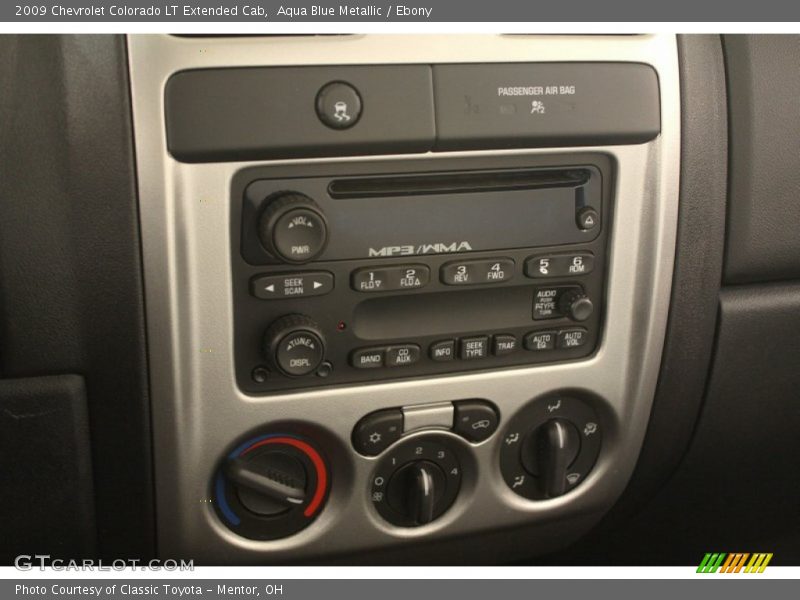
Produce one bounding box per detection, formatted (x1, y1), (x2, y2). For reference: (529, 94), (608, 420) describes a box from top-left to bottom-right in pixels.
(262, 315), (325, 377)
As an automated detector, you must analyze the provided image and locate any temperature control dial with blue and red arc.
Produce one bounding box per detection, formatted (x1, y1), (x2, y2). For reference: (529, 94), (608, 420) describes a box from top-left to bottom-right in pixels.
(214, 433), (330, 540)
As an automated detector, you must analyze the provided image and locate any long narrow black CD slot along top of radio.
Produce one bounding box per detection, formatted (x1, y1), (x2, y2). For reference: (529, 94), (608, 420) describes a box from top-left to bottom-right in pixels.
(328, 169), (591, 199)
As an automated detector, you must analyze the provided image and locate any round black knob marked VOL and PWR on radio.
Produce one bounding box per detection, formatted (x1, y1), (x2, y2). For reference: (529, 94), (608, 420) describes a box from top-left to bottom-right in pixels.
(258, 192), (328, 264)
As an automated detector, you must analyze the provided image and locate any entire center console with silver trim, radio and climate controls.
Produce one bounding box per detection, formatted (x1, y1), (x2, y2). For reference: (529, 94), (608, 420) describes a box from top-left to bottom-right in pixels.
(129, 35), (680, 563)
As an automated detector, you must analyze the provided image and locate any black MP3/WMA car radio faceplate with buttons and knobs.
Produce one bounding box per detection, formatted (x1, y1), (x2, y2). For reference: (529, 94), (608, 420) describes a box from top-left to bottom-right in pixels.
(231, 153), (613, 393)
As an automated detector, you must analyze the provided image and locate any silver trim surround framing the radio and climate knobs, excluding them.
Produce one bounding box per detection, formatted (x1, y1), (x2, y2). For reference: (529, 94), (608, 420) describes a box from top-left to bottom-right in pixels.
(129, 35), (680, 564)
